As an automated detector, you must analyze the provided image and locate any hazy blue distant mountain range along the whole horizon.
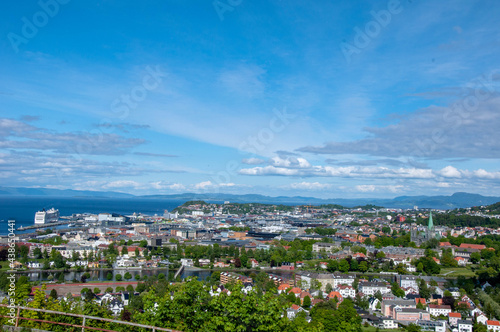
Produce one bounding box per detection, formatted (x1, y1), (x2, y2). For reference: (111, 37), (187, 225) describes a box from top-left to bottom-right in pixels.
(0, 187), (500, 209)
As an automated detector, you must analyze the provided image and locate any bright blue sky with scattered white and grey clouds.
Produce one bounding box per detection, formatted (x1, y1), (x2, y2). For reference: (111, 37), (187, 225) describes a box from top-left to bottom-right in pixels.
(0, 0), (500, 198)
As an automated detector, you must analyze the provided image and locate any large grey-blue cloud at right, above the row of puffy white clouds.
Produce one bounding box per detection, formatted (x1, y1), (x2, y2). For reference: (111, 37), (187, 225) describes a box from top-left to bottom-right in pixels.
(297, 97), (500, 159)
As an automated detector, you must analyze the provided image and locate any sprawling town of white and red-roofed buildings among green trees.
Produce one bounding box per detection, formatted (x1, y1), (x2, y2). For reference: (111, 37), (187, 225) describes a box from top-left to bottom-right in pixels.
(0, 201), (500, 332)
